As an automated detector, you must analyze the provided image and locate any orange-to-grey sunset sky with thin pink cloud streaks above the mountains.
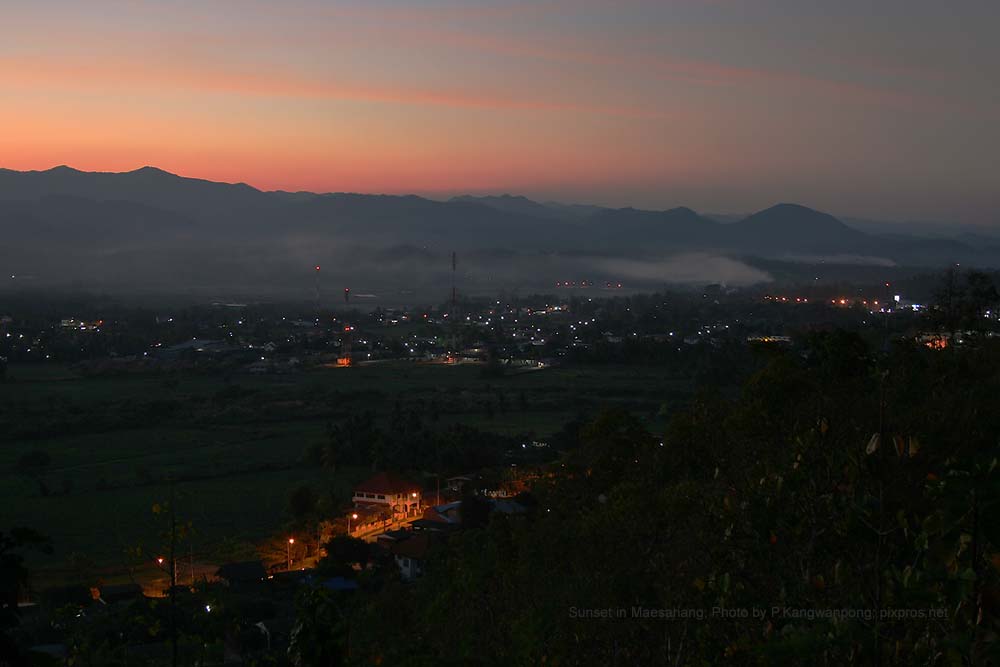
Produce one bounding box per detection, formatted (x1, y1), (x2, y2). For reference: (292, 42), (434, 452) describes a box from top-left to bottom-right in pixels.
(0, 0), (1000, 226)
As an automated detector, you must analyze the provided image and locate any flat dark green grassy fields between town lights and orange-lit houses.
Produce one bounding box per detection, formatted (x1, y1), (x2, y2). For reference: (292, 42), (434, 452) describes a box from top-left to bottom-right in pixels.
(0, 363), (691, 580)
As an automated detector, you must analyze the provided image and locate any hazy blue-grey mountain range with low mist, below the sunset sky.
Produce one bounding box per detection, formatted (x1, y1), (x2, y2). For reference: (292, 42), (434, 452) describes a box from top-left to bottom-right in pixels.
(0, 167), (1000, 291)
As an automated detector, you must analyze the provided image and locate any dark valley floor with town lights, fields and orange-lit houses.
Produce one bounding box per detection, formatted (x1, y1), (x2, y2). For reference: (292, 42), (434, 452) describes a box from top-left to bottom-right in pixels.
(0, 272), (1000, 664)
